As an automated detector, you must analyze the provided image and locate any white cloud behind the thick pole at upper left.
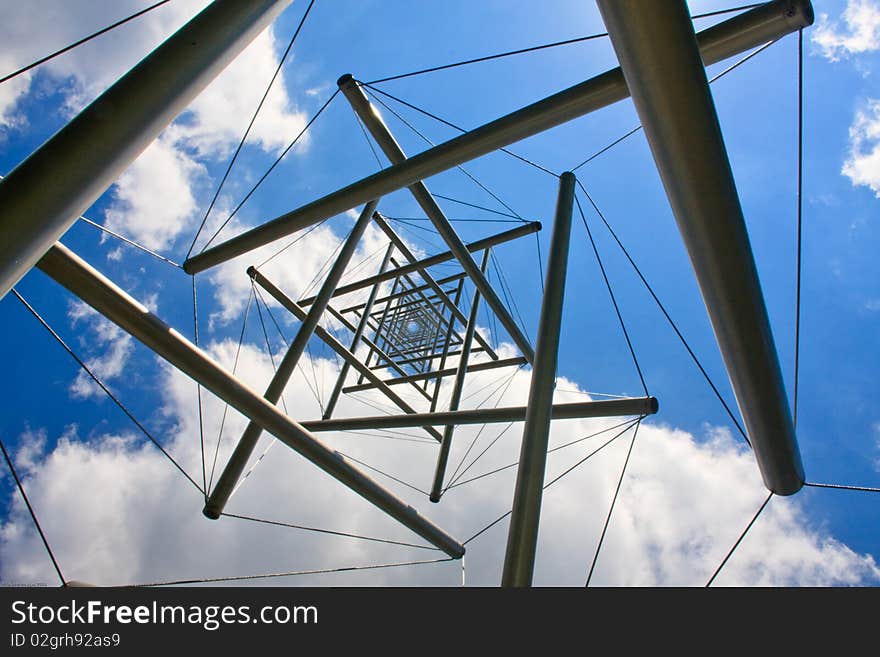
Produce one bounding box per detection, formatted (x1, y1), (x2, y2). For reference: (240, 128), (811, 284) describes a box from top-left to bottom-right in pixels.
(0, 0), (308, 257)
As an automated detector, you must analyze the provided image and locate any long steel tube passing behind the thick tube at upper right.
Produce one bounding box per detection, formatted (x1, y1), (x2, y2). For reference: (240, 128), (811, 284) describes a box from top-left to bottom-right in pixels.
(184, 0), (813, 273)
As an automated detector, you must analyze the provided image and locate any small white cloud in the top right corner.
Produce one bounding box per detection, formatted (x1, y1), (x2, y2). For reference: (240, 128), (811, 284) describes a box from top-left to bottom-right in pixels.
(813, 0), (880, 62)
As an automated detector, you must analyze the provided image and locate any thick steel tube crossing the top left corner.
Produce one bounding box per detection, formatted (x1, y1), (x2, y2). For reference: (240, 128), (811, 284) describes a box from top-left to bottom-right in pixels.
(0, 0), (291, 298)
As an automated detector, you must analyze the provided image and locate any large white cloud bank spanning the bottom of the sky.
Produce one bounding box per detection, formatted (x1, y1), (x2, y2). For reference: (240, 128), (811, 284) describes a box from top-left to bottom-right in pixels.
(0, 341), (880, 585)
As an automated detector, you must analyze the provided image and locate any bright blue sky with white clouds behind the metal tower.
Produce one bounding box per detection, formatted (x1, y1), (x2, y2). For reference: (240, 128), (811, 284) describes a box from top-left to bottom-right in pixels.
(0, 0), (880, 586)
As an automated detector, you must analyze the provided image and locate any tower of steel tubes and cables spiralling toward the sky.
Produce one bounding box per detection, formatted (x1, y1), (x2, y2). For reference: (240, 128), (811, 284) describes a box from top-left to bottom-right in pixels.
(0, 0), (813, 586)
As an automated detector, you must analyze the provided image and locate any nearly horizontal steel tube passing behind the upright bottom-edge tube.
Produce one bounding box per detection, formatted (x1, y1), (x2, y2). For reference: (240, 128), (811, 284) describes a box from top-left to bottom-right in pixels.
(301, 397), (659, 433)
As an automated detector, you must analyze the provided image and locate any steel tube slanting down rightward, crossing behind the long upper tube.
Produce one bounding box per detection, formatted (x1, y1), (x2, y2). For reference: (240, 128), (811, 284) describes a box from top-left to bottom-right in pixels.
(337, 75), (535, 363)
